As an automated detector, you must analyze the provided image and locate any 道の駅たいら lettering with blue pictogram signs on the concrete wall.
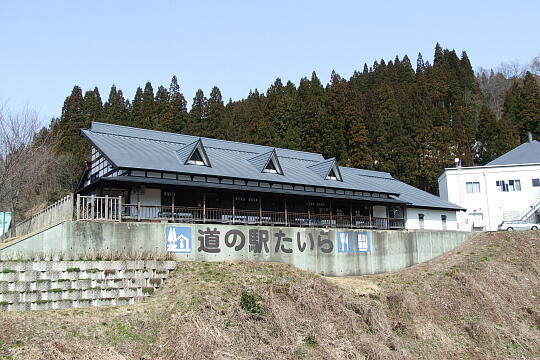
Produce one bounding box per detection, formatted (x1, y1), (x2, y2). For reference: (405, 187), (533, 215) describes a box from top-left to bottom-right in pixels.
(165, 225), (371, 254)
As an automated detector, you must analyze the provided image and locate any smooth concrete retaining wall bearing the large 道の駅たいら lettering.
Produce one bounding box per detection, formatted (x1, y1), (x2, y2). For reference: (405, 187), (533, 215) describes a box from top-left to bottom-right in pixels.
(0, 221), (473, 276)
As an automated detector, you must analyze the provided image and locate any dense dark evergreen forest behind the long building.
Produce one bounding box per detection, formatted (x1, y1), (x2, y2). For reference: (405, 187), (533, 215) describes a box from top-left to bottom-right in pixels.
(2, 44), (540, 219)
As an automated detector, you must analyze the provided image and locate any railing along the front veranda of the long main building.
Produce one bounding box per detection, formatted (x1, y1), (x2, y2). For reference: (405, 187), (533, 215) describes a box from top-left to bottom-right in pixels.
(77, 196), (405, 229)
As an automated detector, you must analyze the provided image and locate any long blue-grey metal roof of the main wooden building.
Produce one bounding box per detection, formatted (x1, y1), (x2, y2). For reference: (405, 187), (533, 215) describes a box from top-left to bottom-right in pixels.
(82, 122), (461, 210)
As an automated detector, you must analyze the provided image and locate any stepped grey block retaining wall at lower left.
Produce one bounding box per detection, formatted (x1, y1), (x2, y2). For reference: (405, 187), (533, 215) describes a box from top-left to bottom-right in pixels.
(0, 260), (176, 311)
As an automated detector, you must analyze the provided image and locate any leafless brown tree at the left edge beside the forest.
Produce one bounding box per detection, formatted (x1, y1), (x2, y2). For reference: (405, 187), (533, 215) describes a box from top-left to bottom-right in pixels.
(0, 105), (54, 234)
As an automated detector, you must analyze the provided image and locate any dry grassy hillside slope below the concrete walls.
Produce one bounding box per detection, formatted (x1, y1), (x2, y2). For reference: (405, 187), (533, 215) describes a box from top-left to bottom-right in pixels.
(0, 232), (540, 359)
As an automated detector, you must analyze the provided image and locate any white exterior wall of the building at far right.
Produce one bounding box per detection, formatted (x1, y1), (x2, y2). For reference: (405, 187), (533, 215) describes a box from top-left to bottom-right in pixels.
(439, 165), (540, 231)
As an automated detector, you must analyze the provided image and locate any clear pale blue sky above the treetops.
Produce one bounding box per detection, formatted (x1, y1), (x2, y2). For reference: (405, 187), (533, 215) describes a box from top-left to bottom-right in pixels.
(0, 0), (540, 123)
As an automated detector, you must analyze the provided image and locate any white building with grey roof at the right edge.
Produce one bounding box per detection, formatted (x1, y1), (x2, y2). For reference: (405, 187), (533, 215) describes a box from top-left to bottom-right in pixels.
(439, 139), (540, 231)
